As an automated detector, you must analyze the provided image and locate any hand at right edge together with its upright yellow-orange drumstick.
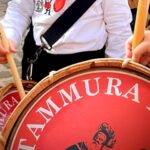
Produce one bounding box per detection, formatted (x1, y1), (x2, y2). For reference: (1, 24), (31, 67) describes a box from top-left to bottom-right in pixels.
(122, 0), (150, 67)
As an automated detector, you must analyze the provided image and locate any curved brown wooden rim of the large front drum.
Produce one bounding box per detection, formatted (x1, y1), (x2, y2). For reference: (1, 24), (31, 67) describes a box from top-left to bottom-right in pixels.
(0, 58), (150, 147)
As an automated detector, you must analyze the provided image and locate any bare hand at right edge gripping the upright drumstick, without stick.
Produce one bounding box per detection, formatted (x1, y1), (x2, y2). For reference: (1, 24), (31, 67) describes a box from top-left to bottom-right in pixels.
(126, 31), (150, 65)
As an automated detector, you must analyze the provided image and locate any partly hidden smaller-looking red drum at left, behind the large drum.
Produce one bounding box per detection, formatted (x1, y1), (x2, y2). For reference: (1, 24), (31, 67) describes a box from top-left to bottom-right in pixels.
(0, 80), (36, 131)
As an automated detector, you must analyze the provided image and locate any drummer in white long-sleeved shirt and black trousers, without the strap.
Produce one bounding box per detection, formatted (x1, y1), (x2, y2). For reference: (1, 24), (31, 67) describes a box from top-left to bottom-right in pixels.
(0, 0), (132, 81)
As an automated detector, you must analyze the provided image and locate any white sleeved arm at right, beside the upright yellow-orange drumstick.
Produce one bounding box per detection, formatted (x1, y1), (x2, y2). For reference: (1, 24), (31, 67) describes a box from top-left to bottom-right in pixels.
(103, 0), (132, 58)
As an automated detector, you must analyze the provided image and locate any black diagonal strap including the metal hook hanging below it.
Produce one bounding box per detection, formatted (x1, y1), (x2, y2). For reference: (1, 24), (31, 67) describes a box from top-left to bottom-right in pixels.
(22, 0), (96, 80)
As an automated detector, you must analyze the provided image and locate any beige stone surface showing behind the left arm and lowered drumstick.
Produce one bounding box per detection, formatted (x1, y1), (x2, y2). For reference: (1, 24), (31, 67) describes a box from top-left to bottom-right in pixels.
(0, 0), (22, 87)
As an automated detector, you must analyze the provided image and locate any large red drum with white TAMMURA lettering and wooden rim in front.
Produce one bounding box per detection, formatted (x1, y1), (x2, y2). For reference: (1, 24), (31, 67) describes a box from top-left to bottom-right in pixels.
(2, 59), (150, 150)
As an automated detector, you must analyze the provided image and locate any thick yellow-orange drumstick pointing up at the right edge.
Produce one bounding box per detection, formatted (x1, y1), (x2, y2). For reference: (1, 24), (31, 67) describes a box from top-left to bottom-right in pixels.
(122, 0), (149, 67)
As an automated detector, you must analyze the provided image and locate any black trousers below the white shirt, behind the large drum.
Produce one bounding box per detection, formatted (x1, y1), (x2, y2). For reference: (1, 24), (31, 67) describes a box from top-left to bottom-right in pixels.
(22, 24), (104, 82)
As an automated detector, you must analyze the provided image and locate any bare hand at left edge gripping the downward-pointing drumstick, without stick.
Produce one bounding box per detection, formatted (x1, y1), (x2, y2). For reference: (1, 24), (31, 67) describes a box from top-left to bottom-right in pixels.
(0, 40), (16, 64)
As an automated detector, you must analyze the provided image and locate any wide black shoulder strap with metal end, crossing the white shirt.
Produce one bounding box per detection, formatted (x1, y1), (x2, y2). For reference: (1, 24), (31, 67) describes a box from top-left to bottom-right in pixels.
(41, 0), (96, 49)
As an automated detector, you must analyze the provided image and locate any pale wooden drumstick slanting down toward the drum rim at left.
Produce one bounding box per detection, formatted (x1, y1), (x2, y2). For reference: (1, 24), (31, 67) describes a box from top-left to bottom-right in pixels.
(0, 24), (25, 99)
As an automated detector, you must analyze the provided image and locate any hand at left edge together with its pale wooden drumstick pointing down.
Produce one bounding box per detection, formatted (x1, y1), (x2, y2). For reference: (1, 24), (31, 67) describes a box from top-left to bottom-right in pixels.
(0, 24), (25, 99)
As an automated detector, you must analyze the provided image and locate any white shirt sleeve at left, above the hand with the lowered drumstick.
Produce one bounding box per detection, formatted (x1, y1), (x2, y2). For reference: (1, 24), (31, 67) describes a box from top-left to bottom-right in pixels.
(2, 0), (34, 46)
